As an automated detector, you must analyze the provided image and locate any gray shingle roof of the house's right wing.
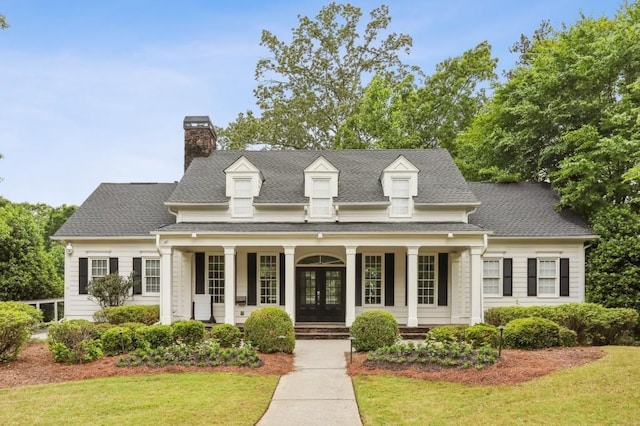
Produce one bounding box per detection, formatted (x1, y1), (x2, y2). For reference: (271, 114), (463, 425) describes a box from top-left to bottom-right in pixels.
(469, 182), (593, 237)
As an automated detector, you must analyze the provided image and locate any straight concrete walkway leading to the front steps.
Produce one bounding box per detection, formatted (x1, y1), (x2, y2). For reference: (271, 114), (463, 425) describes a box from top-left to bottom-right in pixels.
(258, 340), (362, 426)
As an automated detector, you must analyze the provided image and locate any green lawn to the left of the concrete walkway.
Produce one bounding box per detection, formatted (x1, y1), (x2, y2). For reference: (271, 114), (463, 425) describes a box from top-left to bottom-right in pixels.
(0, 373), (278, 426)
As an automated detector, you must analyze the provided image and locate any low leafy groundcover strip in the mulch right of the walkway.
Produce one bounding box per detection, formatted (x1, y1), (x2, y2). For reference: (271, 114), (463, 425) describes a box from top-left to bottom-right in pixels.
(367, 339), (498, 369)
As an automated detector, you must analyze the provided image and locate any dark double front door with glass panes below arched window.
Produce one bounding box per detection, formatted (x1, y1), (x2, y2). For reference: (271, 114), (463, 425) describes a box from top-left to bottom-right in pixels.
(296, 267), (345, 322)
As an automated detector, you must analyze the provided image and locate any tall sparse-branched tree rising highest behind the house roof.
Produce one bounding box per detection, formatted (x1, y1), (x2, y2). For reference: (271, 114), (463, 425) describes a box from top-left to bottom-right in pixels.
(221, 3), (412, 149)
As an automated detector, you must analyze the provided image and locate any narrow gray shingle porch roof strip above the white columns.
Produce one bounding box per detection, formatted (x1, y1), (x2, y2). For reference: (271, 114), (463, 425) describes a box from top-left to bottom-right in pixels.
(159, 222), (484, 233)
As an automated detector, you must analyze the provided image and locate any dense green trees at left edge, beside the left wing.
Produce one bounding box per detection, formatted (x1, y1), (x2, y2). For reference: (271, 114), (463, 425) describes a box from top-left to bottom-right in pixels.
(0, 203), (63, 300)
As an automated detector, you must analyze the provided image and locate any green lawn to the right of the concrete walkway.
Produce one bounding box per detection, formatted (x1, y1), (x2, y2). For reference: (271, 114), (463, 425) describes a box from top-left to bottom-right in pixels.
(353, 347), (640, 425)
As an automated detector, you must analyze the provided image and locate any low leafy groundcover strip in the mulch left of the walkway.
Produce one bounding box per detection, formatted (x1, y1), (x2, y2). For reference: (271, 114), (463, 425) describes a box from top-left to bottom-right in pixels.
(118, 340), (262, 367)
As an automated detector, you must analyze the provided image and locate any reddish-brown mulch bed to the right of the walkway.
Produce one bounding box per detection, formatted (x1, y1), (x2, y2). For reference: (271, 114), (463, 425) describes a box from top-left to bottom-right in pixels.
(347, 347), (604, 385)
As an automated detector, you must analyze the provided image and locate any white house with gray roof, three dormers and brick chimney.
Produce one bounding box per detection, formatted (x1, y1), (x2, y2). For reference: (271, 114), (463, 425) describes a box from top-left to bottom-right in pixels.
(55, 117), (593, 327)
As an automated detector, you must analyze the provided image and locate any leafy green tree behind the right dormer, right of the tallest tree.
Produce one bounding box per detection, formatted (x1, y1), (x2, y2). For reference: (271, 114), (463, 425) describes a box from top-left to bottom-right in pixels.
(337, 42), (497, 156)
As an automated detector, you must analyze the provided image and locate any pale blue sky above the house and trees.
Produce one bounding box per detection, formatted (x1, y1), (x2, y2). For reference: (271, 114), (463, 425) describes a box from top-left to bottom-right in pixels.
(0, 0), (620, 206)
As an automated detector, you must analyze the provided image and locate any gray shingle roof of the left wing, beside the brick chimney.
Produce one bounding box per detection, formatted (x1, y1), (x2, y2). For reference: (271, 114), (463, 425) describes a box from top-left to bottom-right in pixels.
(54, 183), (176, 238)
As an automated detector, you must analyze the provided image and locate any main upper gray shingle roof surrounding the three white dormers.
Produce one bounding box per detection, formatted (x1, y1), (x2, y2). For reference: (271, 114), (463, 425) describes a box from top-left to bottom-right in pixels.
(168, 149), (477, 204)
